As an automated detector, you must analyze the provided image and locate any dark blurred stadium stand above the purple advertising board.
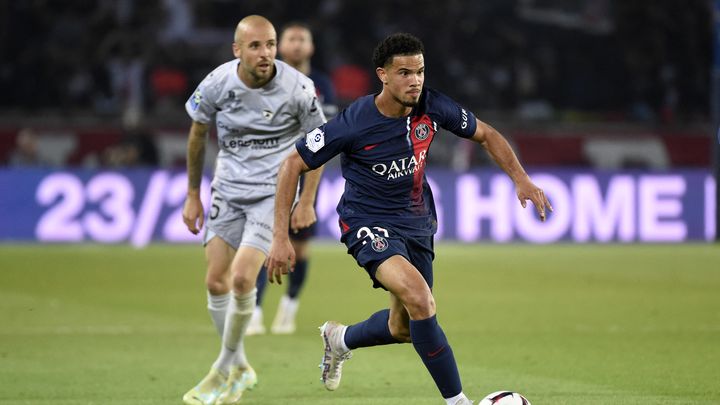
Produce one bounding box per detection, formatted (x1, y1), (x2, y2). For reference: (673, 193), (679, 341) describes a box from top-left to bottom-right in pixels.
(0, 0), (713, 170)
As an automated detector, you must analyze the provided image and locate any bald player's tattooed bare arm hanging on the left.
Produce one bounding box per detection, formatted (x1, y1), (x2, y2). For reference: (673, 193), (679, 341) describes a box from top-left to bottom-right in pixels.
(183, 121), (209, 235)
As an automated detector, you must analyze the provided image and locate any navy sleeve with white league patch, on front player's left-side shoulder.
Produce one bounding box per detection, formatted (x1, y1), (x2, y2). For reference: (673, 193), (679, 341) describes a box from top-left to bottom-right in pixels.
(295, 113), (352, 169)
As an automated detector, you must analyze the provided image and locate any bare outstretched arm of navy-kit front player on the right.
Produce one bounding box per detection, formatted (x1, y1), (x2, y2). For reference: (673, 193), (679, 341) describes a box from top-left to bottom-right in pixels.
(470, 119), (553, 221)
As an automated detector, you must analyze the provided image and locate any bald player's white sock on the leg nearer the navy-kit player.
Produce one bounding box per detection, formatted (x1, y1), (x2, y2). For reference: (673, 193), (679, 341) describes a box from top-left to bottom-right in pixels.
(213, 288), (257, 375)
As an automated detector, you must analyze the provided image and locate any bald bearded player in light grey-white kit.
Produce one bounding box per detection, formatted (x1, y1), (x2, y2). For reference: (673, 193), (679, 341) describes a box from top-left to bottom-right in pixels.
(183, 15), (325, 404)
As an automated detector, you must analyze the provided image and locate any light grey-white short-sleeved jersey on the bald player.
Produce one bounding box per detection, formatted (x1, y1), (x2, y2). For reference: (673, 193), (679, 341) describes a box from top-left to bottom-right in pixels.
(185, 59), (325, 199)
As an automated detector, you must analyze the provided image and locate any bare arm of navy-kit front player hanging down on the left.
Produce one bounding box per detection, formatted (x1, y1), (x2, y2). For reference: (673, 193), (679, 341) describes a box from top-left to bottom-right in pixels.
(265, 150), (310, 284)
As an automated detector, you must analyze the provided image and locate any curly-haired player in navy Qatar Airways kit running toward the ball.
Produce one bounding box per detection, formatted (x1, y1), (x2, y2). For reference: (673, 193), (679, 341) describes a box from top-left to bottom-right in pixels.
(266, 33), (552, 405)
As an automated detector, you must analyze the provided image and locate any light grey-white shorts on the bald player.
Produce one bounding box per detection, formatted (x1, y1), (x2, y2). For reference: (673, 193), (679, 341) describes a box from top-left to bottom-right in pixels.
(203, 190), (275, 255)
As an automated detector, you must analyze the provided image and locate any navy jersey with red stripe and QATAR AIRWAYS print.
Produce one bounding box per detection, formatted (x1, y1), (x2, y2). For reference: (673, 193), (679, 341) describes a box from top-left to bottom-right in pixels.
(295, 88), (476, 235)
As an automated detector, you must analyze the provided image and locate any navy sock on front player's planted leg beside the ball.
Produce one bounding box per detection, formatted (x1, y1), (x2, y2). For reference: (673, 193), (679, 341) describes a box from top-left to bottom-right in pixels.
(410, 315), (462, 398)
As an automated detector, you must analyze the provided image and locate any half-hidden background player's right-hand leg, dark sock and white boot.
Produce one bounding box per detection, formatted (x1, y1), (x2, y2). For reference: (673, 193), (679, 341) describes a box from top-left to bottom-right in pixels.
(270, 238), (309, 335)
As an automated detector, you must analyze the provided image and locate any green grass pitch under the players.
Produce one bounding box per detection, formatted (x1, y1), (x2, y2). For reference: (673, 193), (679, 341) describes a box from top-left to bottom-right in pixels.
(0, 243), (720, 405)
